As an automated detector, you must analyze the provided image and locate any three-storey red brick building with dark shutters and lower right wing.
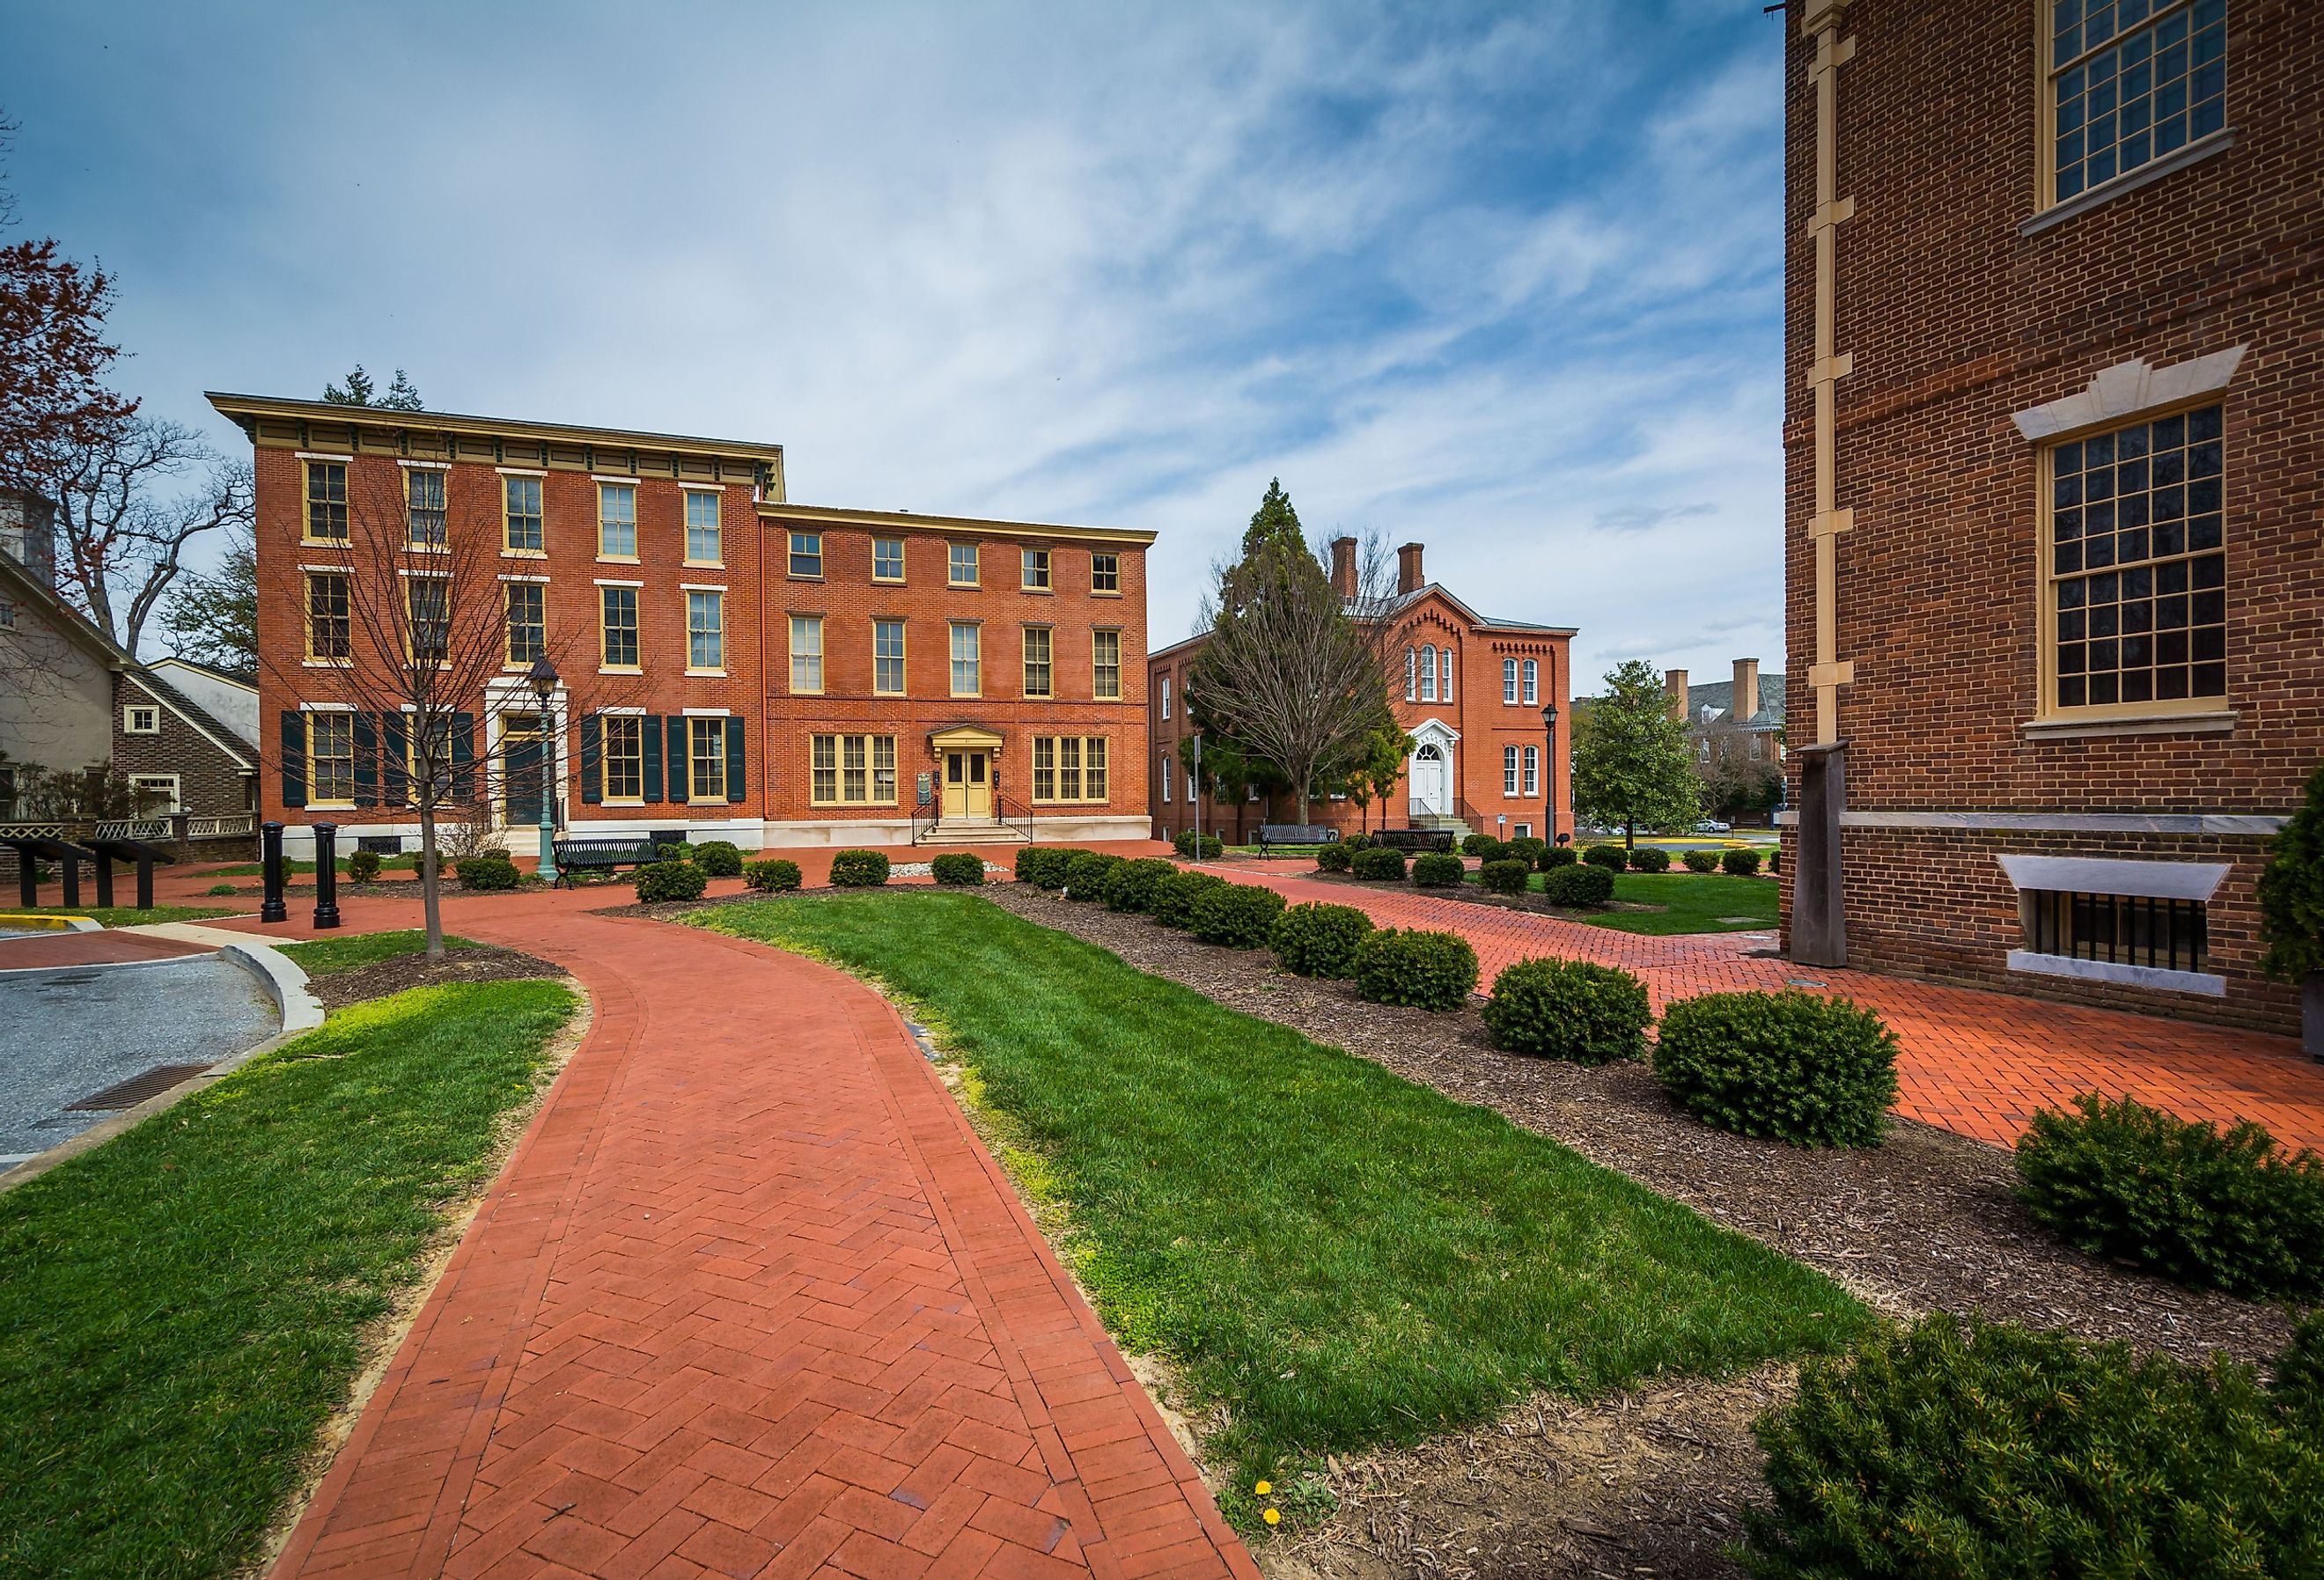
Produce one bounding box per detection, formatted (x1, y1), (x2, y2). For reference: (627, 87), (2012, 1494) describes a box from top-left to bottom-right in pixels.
(210, 395), (1152, 853)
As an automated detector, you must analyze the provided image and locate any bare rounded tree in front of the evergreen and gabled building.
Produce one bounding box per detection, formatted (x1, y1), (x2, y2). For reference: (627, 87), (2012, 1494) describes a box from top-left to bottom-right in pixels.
(1188, 534), (1397, 822)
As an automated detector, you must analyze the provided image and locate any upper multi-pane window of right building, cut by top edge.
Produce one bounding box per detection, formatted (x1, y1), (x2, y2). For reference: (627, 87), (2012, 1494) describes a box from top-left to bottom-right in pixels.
(2049, 0), (2226, 202)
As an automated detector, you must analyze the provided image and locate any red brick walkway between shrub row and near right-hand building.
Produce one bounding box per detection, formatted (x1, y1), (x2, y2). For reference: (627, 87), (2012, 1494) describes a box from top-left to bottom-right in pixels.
(1210, 862), (2324, 1150)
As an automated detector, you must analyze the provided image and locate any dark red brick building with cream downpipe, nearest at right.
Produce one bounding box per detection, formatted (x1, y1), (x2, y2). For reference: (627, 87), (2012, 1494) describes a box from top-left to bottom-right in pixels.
(1785, 0), (2324, 1029)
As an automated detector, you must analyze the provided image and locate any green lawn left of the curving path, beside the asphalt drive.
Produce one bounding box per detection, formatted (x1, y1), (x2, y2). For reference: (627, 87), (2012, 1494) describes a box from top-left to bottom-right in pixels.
(0, 983), (574, 1580)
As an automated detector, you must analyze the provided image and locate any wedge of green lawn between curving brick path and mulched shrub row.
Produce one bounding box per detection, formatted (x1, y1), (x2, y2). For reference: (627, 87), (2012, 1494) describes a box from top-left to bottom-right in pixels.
(690, 894), (1866, 1512)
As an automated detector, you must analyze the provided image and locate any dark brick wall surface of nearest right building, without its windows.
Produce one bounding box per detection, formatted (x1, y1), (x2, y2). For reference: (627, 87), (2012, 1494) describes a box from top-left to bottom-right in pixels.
(1785, 0), (2324, 1029)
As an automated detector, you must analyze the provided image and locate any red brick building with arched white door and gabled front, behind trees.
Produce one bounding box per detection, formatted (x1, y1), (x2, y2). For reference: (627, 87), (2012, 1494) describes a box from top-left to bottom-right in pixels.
(1146, 537), (1573, 841)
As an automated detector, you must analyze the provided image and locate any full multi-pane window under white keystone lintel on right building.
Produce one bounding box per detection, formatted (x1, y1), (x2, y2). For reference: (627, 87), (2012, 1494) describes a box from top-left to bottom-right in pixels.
(2049, 407), (2226, 711)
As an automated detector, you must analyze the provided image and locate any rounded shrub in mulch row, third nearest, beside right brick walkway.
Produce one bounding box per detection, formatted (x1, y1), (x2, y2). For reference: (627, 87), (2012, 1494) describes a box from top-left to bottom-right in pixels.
(1655, 988), (1896, 1145)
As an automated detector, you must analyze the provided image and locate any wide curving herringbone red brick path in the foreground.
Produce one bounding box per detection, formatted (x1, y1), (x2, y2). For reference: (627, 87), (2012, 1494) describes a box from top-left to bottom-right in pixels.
(275, 897), (1257, 1580)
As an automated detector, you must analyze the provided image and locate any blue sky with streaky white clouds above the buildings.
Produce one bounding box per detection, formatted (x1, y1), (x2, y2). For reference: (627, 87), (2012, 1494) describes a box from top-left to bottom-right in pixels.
(0, 0), (1785, 690)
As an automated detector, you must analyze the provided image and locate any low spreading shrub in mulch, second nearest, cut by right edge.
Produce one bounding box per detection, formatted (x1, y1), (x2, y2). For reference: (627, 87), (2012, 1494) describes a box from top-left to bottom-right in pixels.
(2018, 1092), (2324, 1299)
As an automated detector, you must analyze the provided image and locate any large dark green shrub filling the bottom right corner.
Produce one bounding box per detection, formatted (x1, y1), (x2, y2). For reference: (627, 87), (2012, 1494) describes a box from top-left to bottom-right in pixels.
(1743, 1315), (2324, 1580)
